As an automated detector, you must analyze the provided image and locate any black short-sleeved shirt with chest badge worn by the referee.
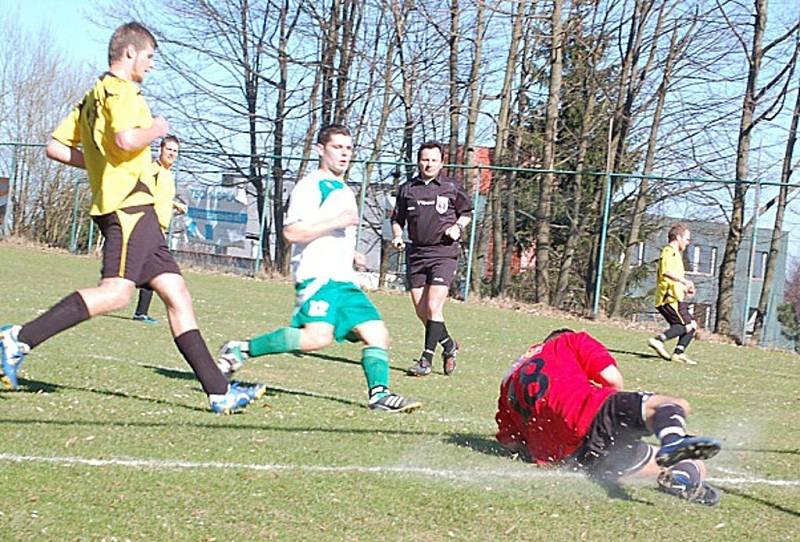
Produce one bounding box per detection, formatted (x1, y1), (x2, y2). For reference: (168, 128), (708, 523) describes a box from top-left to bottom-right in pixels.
(392, 175), (472, 256)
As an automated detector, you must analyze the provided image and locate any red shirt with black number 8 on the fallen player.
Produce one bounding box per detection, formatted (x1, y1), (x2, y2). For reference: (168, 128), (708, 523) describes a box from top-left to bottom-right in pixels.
(495, 332), (617, 464)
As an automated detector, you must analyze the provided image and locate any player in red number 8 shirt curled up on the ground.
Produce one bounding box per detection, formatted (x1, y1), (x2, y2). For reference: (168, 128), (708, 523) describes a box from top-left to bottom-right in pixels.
(495, 329), (720, 506)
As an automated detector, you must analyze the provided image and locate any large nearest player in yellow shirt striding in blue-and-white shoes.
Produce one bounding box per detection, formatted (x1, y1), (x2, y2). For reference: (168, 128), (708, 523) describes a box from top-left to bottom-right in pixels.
(0, 22), (264, 413)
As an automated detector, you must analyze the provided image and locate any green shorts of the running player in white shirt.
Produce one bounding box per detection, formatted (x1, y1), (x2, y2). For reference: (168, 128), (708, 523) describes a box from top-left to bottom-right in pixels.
(292, 279), (382, 342)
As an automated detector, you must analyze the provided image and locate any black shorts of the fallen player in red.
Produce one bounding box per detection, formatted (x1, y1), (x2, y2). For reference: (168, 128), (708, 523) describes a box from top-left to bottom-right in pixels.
(567, 391), (653, 479)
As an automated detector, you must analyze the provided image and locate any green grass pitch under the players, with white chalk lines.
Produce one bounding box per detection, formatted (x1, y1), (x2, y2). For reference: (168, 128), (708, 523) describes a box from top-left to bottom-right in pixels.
(0, 245), (800, 541)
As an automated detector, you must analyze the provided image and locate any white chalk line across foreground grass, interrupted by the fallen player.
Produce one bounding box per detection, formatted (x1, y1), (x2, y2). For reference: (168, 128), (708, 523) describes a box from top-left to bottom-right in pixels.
(0, 453), (800, 487)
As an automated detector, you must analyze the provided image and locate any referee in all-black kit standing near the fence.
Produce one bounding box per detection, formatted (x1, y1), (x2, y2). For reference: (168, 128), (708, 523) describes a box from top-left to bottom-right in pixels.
(392, 141), (472, 376)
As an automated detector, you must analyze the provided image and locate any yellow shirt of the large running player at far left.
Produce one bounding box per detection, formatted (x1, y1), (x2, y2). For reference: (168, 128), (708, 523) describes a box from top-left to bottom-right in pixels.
(53, 73), (154, 215)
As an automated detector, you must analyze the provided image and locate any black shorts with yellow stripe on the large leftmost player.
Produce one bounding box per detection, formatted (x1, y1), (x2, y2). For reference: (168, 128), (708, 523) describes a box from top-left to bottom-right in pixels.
(92, 205), (181, 286)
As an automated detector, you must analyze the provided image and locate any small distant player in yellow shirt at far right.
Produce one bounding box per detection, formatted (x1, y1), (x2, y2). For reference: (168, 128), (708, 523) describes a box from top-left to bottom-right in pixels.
(648, 224), (697, 365)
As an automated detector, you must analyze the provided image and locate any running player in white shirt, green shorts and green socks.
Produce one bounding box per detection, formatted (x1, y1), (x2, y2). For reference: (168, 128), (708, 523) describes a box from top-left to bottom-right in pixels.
(218, 125), (420, 412)
